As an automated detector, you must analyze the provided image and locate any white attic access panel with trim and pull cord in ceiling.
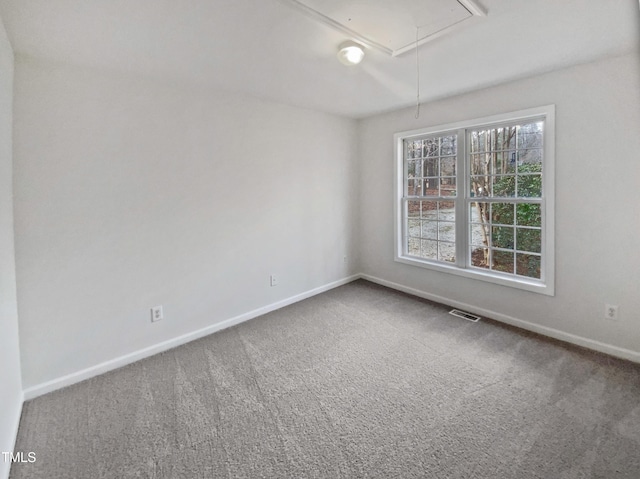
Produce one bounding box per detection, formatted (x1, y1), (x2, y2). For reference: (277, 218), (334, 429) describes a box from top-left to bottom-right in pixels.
(285, 0), (486, 56)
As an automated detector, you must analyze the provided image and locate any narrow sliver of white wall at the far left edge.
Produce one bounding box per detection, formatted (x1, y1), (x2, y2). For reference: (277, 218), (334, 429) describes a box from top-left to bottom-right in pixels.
(0, 12), (22, 477)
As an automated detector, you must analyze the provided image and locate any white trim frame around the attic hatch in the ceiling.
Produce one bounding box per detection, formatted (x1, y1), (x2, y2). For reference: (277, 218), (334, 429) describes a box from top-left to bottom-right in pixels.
(280, 0), (487, 57)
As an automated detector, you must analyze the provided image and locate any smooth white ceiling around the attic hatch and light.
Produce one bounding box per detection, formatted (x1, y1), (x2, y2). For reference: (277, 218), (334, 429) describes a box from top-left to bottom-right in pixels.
(0, 0), (640, 118)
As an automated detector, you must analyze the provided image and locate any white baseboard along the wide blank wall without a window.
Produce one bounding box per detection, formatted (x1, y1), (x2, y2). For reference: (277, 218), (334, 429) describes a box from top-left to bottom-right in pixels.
(24, 274), (360, 401)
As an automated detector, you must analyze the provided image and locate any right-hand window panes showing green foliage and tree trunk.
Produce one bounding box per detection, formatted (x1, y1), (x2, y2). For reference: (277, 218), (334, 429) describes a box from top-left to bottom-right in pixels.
(468, 121), (544, 278)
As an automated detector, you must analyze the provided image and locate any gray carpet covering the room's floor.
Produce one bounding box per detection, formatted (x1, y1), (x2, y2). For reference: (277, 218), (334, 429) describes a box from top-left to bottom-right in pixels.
(11, 281), (640, 479)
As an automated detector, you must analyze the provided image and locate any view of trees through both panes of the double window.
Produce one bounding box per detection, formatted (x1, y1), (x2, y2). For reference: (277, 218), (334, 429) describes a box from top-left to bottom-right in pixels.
(403, 121), (544, 279)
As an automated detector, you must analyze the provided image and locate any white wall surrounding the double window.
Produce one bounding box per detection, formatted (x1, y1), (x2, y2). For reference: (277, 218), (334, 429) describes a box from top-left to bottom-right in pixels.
(359, 52), (640, 361)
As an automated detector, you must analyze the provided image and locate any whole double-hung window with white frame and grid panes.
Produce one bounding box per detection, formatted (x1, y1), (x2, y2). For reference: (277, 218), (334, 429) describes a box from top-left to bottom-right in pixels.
(395, 106), (555, 295)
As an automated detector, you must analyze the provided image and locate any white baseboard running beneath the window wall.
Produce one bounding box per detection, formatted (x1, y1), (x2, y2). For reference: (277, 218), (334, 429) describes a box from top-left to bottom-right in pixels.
(360, 274), (640, 363)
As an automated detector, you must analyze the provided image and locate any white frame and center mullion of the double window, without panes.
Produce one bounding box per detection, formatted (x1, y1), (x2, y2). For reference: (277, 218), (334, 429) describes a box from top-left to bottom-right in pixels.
(394, 105), (555, 296)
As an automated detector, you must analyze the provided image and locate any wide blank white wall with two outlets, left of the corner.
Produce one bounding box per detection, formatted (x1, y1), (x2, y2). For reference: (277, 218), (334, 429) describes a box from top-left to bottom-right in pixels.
(14, 56), (357, 388)
